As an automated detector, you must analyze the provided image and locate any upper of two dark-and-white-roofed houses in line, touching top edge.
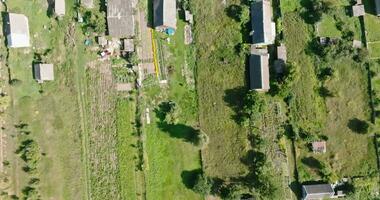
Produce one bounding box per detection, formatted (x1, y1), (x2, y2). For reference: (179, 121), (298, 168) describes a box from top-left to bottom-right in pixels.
(251, 0), (276, 46)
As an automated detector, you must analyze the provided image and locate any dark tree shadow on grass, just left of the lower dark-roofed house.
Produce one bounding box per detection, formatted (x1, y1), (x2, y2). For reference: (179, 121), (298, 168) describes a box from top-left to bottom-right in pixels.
(223, 87), (247, 124)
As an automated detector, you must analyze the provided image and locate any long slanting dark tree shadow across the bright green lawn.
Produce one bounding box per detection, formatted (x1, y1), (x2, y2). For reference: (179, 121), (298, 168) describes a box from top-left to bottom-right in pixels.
(158, 121), (200, 145)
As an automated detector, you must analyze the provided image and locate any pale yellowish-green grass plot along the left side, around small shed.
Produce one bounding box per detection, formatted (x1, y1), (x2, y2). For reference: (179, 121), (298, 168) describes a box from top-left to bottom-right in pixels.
(3, 0), (86, 199)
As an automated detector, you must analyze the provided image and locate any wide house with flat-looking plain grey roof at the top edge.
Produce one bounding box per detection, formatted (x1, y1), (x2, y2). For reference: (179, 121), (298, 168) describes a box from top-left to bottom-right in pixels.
(107, 0), (135, 38)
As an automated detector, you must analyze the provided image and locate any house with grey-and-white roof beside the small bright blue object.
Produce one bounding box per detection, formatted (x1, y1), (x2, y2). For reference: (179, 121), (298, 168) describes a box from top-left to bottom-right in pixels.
(153, 0), (177, 35)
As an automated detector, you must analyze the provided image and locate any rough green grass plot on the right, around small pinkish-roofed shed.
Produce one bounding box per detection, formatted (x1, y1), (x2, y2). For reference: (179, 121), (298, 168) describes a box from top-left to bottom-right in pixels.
(284, 9), (375, 183)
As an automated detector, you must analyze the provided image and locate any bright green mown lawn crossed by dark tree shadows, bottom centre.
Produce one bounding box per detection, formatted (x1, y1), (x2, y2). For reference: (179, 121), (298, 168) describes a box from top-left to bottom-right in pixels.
(142, 17), (201, 199)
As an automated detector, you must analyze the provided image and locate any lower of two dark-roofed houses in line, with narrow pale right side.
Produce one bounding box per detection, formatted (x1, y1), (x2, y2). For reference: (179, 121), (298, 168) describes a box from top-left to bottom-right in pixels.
(249, 53), (269, 92)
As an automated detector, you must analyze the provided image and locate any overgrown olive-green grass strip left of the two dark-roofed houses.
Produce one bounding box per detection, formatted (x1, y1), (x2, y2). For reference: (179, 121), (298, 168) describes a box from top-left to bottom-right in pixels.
(191, 0), (247, 178)
